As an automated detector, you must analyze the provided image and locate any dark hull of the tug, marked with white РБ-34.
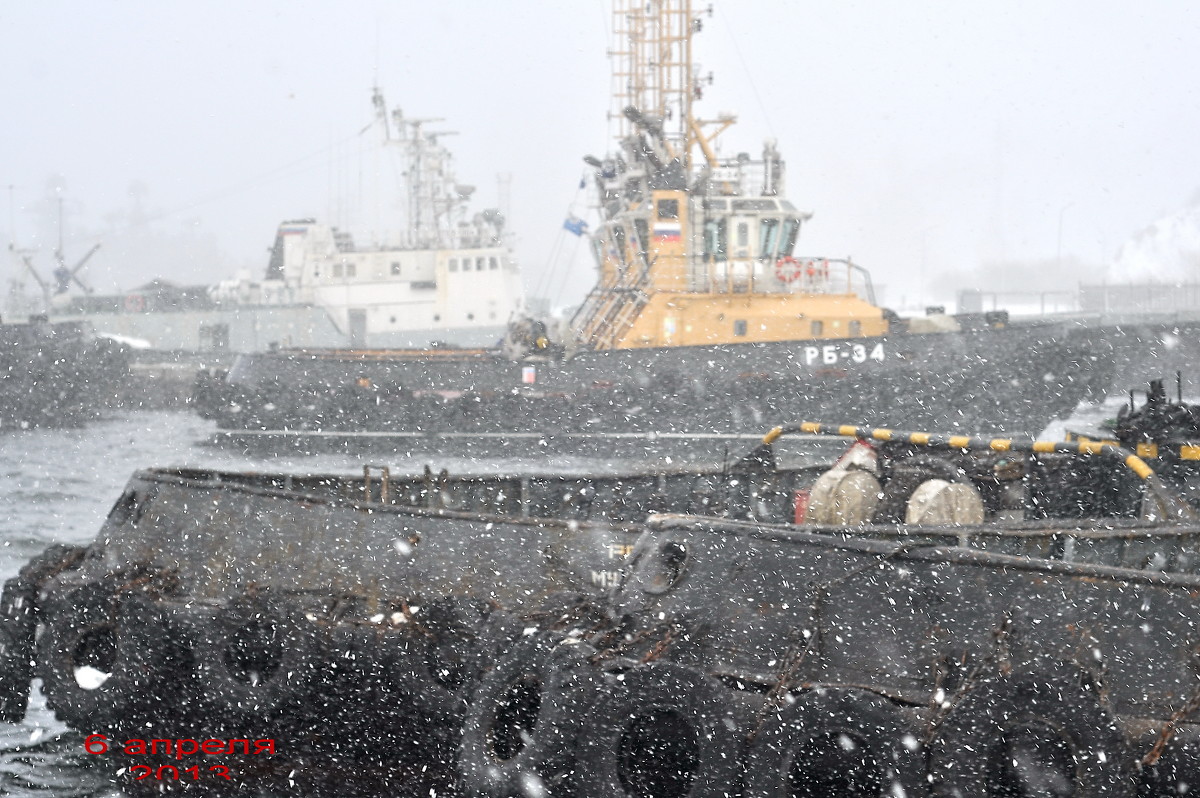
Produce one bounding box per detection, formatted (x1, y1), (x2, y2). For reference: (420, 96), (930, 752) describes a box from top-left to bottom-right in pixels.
(199, 325), (1111, 436)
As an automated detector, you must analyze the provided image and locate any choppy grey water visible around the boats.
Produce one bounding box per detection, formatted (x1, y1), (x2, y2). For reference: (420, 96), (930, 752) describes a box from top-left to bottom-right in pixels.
(0, 398), (1121, 798)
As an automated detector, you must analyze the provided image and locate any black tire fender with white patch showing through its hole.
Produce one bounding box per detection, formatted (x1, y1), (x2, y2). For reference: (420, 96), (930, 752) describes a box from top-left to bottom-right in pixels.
(37, 580), (162, 733)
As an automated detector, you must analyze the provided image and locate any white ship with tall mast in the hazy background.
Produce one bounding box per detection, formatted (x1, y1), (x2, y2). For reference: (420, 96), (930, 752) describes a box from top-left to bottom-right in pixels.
(14, 89), (523, 353)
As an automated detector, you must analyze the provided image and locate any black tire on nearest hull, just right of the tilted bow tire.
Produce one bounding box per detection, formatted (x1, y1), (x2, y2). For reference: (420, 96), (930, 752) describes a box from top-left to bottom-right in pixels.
(574, 662), (749, 798)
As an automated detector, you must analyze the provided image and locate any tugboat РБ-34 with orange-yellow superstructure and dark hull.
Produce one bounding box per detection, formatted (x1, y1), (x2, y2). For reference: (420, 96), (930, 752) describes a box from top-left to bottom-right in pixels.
(197, 1), (1108, 445)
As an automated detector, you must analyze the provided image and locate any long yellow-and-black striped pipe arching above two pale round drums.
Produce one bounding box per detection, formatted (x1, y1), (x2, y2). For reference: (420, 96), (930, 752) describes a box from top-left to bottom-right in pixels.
(762, 421), (1154, 480)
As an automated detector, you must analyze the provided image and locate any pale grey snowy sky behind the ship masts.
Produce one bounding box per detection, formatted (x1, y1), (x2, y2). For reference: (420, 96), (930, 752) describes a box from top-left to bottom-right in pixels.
(0, 0), (1200, 305)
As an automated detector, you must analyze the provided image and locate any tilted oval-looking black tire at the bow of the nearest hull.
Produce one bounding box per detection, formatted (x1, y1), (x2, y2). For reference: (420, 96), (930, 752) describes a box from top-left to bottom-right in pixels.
(458, 632), (604, 798)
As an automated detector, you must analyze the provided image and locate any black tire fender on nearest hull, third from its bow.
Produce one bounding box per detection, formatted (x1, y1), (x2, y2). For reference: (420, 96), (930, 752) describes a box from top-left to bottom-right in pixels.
(745, 688), (928, 798)
